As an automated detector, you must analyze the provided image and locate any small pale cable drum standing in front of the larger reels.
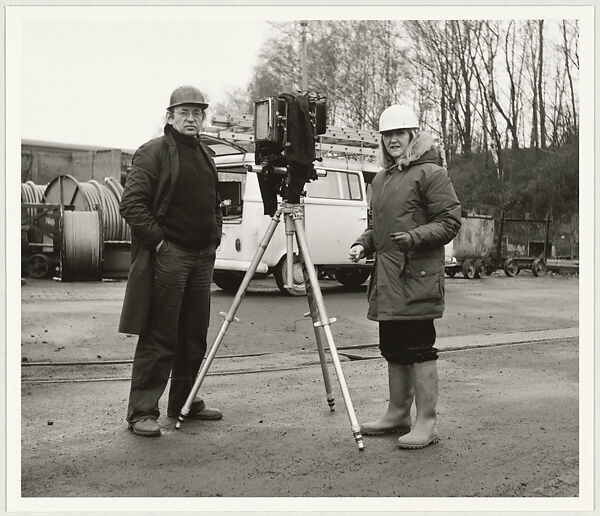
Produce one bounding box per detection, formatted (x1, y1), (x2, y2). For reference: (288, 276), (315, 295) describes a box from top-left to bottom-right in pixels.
(61, 210), (103, 281)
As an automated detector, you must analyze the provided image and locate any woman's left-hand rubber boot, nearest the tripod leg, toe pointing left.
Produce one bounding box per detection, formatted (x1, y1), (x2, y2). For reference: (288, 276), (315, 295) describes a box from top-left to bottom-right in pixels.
(360, 362), (413, 435)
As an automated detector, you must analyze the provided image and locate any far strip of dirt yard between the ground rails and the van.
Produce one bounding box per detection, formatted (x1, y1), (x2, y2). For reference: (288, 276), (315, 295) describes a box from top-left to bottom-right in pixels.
(21, 271), (579, 361)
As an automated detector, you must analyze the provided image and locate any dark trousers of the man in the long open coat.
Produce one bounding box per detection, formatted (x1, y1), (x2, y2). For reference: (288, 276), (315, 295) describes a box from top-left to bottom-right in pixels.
(127, 242), (215, 422)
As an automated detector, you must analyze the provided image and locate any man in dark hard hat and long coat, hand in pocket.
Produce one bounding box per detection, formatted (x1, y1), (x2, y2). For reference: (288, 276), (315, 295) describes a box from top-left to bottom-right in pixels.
(119, 86), (222, 436)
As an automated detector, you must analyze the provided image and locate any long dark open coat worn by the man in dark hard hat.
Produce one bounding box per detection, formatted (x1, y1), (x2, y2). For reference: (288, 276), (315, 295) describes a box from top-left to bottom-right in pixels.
(119, 126), (222, 334)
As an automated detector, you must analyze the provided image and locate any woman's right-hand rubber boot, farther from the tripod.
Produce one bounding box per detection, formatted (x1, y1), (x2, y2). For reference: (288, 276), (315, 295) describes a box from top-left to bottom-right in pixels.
(398, 360), (439, 449)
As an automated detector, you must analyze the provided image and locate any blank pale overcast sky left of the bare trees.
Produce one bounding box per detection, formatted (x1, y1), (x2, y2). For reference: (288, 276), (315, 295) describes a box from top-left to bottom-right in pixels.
(21, 16), (268, 148)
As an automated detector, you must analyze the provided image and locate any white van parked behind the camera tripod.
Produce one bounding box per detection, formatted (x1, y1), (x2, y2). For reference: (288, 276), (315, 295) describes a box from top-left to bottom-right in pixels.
(213, 153), (378, 295)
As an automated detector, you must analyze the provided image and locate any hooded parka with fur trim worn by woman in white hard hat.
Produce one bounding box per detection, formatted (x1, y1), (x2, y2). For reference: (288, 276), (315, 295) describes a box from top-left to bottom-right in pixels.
(356, 133), (461, 321)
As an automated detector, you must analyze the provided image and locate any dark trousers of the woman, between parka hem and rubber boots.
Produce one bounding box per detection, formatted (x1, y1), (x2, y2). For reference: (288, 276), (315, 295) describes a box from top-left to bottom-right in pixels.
(379, 319), (437, 365)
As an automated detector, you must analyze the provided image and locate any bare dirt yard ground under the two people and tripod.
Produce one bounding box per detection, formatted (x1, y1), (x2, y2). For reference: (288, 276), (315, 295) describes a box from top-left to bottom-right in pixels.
(16, 274), (579, 510)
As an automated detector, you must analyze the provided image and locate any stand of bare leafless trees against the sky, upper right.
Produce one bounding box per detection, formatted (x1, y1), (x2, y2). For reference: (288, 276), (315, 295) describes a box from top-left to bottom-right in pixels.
(249, 20), (579, 157)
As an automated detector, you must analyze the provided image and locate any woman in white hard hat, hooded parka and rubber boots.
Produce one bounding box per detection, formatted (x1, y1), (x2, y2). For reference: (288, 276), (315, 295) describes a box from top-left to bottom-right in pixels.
(349, 105), (461, 449)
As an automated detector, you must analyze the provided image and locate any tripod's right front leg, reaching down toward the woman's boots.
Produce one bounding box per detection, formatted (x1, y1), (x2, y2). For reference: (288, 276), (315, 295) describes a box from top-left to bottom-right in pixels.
(294, 217), (364, 451)
